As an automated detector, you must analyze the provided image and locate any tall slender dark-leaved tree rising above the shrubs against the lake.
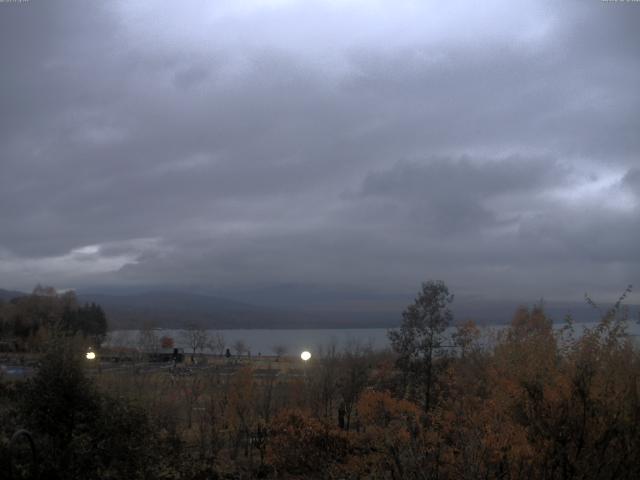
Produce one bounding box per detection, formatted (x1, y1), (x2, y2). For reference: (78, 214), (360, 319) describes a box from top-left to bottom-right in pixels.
(388, 281), (453, 412)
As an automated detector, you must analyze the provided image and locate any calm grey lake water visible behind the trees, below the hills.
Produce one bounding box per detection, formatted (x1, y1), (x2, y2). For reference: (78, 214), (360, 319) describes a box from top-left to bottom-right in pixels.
(105, 322), (640, 355)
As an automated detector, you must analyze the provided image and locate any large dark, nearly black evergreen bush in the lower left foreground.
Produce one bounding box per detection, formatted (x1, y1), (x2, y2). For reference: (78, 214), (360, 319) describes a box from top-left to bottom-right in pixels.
(17, 331), (167, 480)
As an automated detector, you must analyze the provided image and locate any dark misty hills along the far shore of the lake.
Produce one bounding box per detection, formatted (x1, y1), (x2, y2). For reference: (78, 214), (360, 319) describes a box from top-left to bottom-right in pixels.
(0, 289), (639, 329)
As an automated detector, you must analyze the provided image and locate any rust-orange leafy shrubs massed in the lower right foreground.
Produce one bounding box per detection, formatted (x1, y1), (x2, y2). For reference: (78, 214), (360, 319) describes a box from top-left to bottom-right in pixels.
(264, 308), (640, 479)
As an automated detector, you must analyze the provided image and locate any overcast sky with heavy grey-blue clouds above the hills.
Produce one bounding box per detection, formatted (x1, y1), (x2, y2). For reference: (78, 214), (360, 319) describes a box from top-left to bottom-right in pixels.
(0, 0), (640, 300)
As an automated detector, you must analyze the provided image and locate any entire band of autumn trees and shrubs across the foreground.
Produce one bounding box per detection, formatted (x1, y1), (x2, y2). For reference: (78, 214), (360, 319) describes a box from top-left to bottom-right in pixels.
(0, 284), (640, 480)
